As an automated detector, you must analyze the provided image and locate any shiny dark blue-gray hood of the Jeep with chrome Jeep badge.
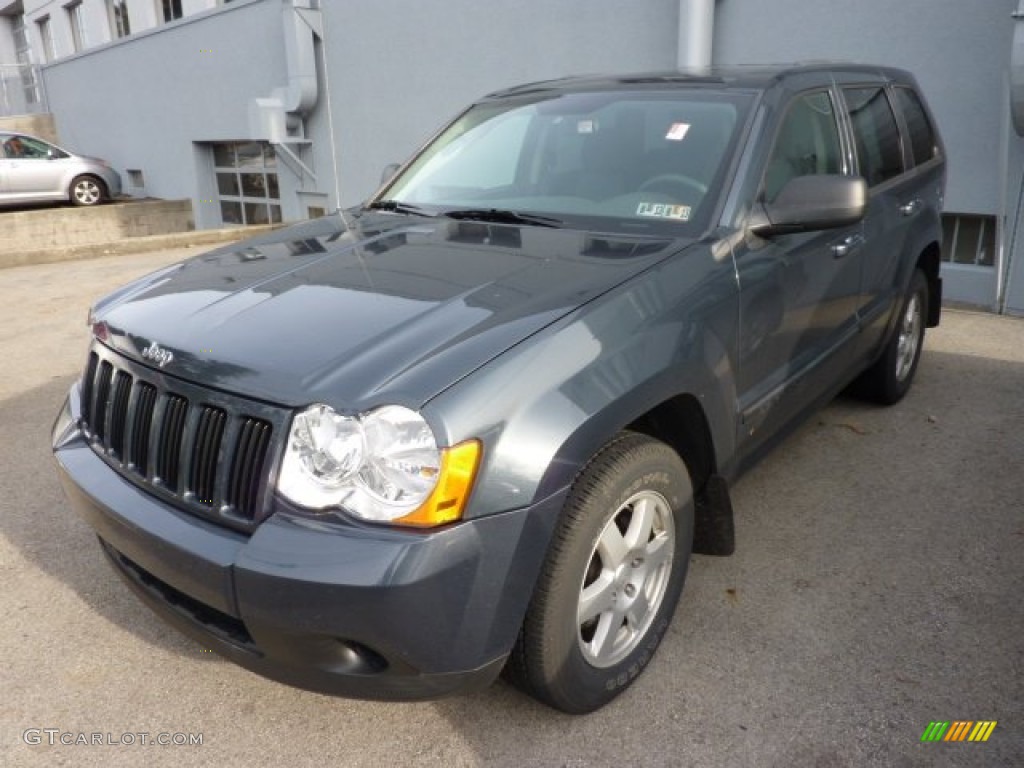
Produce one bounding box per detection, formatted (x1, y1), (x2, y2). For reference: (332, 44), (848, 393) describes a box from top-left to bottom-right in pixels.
(92, 212), (686, 411)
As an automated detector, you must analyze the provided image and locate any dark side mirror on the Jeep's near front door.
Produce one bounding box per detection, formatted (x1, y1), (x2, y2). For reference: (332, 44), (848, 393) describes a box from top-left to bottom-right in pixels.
(749, 174), (867, 238)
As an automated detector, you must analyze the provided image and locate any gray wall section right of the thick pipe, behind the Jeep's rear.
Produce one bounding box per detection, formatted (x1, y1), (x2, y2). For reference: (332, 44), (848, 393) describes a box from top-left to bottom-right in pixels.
(714, 0), (1024, 306)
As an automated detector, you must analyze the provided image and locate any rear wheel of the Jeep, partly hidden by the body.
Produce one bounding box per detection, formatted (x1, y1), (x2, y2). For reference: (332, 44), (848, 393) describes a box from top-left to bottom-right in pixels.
(855, 269), (928, 406)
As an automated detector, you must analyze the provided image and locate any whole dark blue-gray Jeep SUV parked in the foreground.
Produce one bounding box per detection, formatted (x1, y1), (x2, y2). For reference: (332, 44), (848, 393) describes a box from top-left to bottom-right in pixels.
(53, 66), (945, 713)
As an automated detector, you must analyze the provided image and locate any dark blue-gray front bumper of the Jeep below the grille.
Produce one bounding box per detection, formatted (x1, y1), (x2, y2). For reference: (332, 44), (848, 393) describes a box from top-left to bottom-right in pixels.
(53, 390), (561, 699)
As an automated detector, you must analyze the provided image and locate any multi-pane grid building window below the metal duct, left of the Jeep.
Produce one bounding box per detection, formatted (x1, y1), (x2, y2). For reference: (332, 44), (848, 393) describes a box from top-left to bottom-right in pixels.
(213, 141), (281, 224)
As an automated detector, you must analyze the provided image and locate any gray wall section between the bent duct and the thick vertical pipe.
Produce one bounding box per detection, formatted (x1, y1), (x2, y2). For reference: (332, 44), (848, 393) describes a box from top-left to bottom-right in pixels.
(318, 0), (679, 205)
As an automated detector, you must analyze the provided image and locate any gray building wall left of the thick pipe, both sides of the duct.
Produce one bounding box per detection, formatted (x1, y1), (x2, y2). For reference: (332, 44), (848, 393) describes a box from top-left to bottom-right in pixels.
(36, 0), (679, 227)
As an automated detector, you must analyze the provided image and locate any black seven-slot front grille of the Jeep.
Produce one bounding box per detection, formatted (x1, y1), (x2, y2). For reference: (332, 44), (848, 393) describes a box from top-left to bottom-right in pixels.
(81, 345), (287, 529)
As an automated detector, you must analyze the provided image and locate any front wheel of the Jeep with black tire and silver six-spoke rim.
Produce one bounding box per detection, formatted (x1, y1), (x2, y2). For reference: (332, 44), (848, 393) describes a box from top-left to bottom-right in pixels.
(506, 432), (693, 714)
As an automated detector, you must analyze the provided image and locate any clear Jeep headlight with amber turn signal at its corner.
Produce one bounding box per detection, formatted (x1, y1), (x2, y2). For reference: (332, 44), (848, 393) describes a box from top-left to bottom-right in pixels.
(278, 404), (480, 525)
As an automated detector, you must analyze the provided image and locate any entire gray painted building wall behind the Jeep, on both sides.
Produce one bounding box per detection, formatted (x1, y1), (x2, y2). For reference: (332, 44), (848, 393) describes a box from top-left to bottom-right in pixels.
(28, 0), (1024, 311)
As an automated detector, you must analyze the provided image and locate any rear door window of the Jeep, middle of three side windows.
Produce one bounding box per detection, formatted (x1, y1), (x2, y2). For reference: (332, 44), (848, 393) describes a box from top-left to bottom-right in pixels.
(843, 86), (903, 186)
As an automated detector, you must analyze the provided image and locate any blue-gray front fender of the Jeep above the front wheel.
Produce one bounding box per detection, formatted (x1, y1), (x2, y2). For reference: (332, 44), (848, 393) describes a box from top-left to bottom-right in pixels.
(425, 245), (737, 517)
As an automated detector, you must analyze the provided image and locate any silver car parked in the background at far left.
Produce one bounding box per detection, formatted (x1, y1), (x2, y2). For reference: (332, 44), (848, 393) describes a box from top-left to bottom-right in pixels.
(0, 131), (121, 206)
